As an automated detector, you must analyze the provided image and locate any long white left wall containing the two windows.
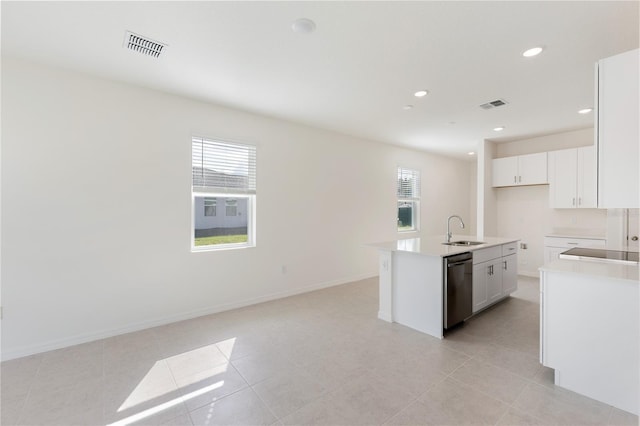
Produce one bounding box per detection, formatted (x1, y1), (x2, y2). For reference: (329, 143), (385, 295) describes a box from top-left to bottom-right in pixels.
(2, 58), (471, 359)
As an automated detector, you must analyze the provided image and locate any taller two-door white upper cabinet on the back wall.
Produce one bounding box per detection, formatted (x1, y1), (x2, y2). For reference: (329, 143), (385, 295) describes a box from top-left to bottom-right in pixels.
(549, 146), (597, 209)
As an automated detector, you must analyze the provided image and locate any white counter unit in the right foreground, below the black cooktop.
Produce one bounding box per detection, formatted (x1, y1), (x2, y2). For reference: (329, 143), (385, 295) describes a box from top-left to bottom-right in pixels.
(540, 260), (640, 415)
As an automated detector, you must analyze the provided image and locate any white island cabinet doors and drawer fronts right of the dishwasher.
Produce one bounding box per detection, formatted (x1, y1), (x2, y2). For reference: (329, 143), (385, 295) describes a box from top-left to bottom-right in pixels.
(472, 243), (518, 312)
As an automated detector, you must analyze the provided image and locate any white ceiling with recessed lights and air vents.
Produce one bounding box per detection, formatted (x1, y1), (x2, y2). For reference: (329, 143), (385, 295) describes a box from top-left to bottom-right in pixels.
(1, 1), (639, 157)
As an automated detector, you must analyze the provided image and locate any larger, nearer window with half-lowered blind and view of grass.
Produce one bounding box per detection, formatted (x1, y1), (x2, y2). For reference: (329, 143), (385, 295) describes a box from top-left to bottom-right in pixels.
(191, 137), (256, 251)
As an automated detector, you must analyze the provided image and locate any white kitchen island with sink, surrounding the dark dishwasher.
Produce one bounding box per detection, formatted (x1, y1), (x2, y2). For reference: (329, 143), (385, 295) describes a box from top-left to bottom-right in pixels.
(371, 235), (518, 339)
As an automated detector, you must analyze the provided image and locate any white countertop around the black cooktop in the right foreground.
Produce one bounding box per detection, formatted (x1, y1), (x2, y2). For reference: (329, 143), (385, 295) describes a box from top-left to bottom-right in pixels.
(540, 259), (640, 283)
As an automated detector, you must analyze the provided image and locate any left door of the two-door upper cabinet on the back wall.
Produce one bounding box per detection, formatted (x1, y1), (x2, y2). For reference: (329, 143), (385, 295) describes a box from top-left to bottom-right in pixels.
(549, 148), (578, 209)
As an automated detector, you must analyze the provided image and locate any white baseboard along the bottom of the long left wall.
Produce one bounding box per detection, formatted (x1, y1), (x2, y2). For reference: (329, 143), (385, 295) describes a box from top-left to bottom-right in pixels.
(0, 274), (377, 361)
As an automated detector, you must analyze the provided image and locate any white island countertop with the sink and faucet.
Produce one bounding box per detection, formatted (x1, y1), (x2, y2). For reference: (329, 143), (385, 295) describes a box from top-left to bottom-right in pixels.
(367, 235), (519, 257)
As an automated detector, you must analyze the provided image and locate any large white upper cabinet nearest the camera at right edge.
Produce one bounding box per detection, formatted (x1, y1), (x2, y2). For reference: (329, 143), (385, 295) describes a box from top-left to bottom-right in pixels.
(596, 49), (640, 208)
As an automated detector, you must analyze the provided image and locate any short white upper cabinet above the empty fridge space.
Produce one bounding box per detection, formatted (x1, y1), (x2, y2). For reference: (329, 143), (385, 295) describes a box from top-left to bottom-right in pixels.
(492, 152), (549, 187)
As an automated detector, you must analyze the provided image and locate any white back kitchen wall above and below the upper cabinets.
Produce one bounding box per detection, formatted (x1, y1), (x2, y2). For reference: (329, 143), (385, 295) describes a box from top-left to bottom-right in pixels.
(493, 129), (607, 276)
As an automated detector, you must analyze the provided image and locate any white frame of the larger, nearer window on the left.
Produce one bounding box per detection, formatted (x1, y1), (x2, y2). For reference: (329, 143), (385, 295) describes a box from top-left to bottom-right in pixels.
(190, 136), (257, 253)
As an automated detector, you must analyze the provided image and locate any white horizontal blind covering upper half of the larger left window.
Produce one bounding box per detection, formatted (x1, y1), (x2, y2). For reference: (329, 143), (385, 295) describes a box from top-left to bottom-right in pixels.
(191, 137), (256, 194)
